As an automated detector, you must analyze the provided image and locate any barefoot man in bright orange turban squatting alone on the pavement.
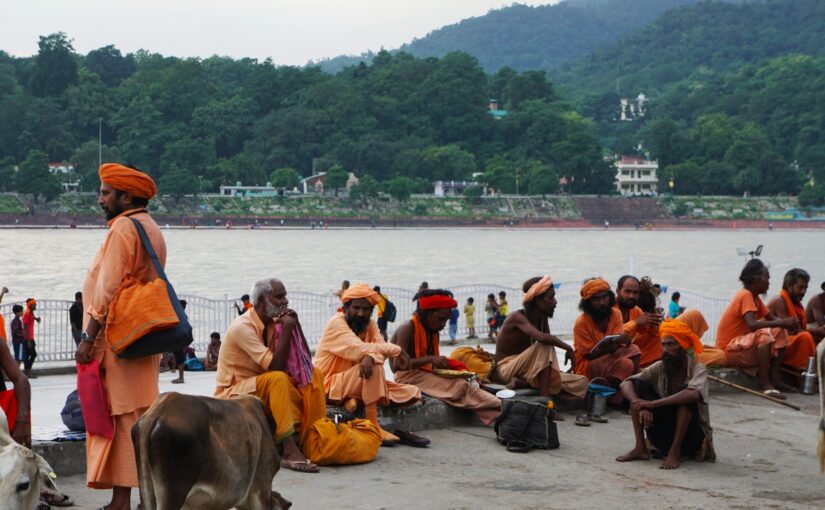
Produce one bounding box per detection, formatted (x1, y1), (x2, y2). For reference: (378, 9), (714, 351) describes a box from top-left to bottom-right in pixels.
(616, 319), (716, 469)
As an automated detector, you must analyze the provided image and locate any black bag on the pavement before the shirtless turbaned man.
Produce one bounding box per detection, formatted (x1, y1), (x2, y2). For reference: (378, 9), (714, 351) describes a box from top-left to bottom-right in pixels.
(495, 400), (559, 453)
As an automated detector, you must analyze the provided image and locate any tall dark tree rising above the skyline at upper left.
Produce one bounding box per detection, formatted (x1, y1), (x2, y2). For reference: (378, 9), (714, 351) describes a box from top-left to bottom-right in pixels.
(29, 32), (77, 97)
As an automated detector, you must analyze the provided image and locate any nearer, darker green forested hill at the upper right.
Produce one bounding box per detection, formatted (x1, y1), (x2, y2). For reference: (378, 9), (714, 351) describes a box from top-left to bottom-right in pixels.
(552, 0), (825, 97)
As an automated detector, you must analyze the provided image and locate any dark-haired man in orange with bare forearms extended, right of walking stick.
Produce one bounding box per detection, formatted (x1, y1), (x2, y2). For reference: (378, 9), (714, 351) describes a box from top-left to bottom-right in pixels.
(716, 259), (799, 398)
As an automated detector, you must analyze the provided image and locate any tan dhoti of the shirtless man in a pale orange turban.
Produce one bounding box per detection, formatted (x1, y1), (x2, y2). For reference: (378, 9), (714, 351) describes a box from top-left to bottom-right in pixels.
(496, 342), (587, 398)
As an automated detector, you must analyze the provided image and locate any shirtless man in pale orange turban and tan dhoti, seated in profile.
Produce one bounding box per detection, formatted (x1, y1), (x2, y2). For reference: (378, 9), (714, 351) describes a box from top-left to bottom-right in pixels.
(496, 275), (587, 398)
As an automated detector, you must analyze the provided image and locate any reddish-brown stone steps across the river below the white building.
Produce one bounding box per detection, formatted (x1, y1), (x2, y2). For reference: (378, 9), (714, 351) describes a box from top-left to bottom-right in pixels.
(573, 196), (670, 224)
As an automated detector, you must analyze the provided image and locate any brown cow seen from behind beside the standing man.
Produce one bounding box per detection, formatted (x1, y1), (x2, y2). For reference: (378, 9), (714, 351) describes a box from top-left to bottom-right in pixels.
(132, 392), (292, 510)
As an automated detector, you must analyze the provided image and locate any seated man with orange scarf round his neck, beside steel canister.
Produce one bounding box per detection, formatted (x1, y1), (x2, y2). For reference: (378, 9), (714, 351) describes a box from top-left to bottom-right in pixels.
(768, 269), (817, 370)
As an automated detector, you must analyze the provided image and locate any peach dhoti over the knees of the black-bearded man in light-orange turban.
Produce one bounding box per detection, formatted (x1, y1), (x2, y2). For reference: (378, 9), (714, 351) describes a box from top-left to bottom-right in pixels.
(326, 363), (421, 406)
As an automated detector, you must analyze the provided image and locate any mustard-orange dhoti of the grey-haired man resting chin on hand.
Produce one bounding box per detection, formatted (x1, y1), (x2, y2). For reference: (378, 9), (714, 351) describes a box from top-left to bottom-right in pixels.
(254, 369), (327, 445)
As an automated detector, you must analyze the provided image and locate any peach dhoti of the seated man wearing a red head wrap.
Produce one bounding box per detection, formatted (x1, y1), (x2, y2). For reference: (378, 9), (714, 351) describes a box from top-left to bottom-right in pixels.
(395, 370), (501, 425)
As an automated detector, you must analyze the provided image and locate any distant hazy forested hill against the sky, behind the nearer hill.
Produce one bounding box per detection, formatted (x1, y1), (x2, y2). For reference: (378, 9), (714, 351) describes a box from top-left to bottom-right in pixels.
(318, 0), (697, 73)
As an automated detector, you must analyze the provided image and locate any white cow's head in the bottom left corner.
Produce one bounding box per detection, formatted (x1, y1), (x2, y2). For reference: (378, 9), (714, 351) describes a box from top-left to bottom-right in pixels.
(0, 406), (57, 510)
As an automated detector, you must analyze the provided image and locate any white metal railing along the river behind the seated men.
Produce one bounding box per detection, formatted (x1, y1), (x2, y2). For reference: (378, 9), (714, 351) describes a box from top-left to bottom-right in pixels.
(0, 282), (727, 362)
